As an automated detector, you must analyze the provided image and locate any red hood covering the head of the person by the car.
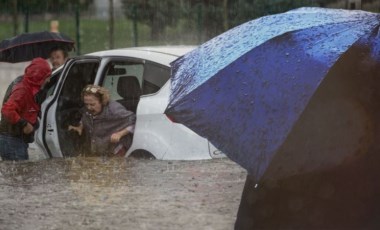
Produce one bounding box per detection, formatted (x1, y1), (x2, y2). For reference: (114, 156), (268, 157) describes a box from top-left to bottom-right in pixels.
(24, 58), (51, 89)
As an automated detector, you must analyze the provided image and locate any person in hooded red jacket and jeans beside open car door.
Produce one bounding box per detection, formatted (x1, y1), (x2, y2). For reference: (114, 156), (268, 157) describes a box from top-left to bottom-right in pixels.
(0, 58), (51, 161)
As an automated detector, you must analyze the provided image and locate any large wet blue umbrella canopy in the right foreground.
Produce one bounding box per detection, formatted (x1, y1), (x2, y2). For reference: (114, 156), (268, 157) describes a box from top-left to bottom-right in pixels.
(165, 8), (380, 180)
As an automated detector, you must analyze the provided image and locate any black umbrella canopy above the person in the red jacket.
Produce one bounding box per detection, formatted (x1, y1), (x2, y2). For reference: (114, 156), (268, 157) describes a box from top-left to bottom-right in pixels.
(0, 31), (74, 63)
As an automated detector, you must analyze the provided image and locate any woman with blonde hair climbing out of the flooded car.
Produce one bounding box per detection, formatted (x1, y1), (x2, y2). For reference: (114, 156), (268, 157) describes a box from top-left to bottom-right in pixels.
(69, 85), (136, 156)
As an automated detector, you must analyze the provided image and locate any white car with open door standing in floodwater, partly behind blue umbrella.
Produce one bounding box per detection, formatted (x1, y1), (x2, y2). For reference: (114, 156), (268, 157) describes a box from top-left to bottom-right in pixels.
(35, 46), (225, 160)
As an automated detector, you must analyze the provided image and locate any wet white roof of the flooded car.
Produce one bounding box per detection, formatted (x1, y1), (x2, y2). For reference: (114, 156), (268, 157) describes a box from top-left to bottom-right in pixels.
(85, 46), (197, 66)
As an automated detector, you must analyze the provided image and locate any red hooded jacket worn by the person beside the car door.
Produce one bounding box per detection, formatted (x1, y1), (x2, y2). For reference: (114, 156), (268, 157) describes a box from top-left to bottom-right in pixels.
(1, 58), (51, 131)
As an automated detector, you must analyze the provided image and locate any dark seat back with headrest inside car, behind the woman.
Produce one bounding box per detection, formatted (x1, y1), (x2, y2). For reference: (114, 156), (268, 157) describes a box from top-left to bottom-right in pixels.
(117, 76), (141, 113)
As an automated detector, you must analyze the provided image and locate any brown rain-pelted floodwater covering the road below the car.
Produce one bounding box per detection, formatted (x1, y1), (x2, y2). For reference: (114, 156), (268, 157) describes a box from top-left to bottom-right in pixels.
(0, 157), (246, 230)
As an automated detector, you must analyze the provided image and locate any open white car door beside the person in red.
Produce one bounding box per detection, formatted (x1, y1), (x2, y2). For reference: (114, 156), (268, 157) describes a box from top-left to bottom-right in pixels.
(36, 57), (100, 157)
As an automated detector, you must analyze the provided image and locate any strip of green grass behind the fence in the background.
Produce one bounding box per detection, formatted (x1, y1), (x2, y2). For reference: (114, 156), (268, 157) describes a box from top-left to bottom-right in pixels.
(0, 16), (200, 54)
